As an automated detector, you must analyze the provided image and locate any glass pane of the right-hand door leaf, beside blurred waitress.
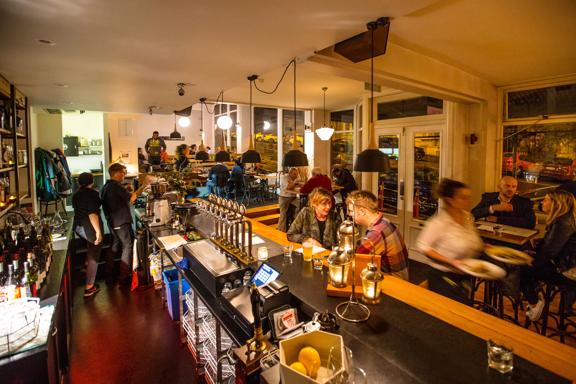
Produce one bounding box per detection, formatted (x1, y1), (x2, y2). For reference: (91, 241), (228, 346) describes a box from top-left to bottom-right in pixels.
(412, 132), (440, 220)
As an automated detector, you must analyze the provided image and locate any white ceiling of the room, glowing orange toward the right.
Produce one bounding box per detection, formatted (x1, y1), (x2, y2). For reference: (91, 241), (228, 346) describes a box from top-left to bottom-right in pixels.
(0, 0), (576, 113)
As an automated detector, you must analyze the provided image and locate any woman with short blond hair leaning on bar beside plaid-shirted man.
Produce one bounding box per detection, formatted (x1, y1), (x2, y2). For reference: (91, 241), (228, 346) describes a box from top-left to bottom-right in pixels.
(286, 187), (341, 249)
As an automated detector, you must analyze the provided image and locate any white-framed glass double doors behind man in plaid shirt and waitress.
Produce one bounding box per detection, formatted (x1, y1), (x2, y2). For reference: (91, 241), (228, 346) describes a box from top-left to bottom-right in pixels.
(376, 125), (443, 253)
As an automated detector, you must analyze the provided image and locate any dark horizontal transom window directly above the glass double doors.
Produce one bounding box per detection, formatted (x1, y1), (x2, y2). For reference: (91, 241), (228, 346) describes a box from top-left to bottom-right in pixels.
(377, 96), (443, 120)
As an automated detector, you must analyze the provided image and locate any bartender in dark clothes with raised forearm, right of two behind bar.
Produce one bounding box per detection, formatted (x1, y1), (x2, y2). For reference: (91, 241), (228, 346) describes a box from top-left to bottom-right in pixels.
(101, 163), (148, 285)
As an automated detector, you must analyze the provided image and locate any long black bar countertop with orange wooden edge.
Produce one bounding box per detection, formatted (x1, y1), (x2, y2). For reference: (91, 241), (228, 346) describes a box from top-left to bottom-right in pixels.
(141, 210), (576, 383)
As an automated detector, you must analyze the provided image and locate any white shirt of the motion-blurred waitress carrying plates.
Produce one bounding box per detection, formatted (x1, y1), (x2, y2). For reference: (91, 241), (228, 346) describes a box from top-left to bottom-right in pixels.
(416, 209), (484, 271)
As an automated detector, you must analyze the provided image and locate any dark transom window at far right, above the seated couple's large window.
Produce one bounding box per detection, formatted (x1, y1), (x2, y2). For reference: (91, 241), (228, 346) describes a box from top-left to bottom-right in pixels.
(507, 84), (576, 119)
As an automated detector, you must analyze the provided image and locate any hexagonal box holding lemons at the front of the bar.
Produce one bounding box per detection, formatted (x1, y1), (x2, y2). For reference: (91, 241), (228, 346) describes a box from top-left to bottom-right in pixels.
(280, 331), (346, 384)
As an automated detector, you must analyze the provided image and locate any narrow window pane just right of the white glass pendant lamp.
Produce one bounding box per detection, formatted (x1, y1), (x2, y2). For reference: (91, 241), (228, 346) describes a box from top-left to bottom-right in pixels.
(330, 109), (354, 169)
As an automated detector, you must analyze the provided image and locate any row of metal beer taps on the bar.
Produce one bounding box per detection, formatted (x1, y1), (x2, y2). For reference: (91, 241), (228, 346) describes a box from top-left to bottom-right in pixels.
(198, 194), (254, 263)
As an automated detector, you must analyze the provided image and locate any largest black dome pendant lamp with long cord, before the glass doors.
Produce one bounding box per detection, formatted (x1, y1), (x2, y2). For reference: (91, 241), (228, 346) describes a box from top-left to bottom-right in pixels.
(354, 18), (390, 172)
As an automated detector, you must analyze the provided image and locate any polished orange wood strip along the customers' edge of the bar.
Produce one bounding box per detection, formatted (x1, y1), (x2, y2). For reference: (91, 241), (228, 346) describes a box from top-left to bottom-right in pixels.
(248, 219), (576, 382)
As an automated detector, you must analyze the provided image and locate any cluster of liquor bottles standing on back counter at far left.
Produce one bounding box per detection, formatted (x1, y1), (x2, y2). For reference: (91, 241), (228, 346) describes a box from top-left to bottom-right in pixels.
(0, 219), (54, 302)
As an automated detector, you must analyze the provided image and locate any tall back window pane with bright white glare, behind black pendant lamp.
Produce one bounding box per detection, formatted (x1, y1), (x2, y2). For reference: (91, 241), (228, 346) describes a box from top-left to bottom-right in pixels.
(254, 107), (278, 172)
